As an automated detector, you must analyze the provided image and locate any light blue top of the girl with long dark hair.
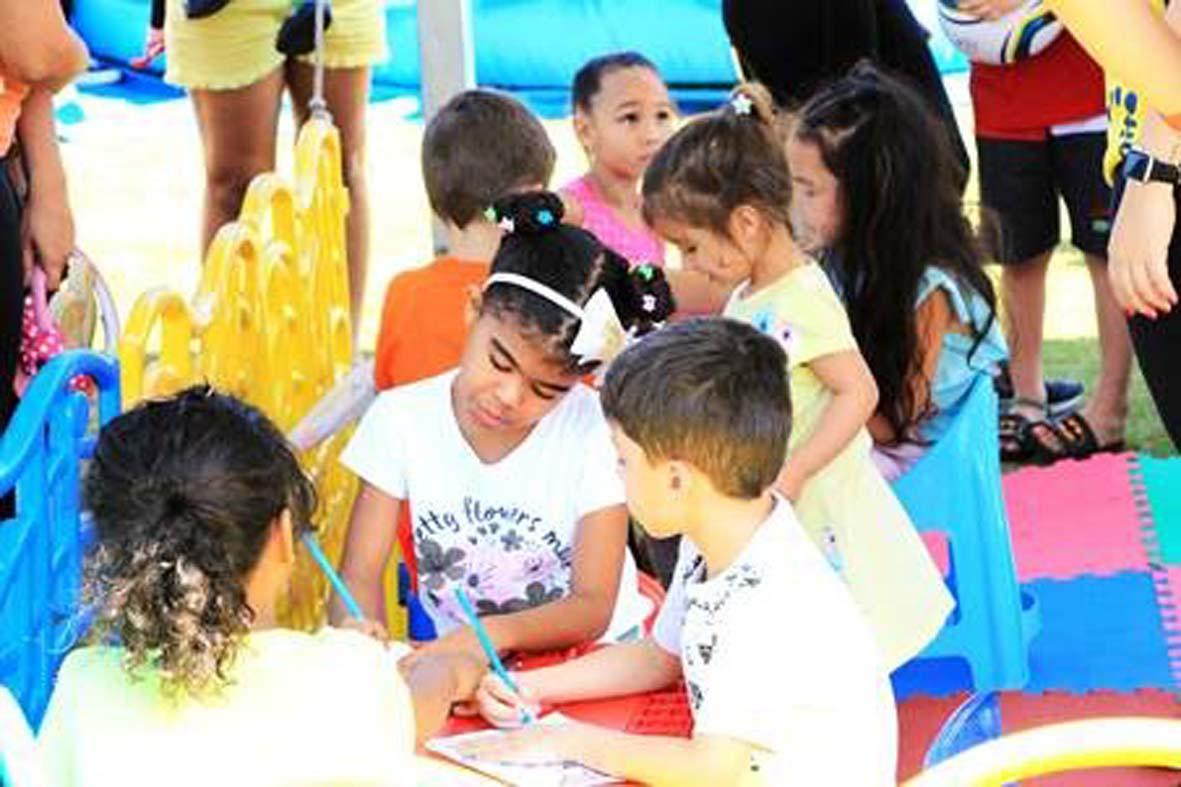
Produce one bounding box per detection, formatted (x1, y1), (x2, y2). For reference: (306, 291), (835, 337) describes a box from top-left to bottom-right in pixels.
(915, 266), (1009, 443)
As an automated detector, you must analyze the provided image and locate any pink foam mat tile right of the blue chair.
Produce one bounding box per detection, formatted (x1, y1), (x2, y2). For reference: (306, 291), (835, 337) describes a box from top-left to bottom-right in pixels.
(1003, 446), (1148, 581)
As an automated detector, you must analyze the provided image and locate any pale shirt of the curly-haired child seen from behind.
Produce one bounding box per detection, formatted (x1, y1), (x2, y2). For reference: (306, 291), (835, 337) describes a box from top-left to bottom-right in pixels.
(38, 629), (417, 787)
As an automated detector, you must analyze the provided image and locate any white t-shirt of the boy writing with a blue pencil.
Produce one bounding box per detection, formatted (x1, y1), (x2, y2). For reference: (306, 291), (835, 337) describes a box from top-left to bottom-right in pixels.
(653, 500), (898, 787)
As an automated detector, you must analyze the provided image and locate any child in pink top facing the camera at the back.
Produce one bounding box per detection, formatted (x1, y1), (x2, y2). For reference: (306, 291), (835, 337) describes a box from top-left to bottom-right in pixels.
(562, 52), (725, 313)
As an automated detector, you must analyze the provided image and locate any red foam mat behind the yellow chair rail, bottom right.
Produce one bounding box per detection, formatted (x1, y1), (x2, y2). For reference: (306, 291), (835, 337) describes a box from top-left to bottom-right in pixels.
(899, 691), (1181, 787)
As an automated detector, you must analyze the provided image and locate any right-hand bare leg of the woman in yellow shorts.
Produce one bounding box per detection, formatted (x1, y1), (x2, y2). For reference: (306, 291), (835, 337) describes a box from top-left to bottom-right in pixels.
(287, 61), (370, 337)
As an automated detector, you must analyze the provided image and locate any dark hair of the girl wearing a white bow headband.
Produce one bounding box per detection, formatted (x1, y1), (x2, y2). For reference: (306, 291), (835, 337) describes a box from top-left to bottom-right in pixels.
(481, 191), (676, 375)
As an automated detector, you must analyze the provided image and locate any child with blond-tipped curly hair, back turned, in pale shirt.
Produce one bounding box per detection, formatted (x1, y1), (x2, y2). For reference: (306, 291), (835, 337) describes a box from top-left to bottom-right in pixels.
(39, 386), (482, 785)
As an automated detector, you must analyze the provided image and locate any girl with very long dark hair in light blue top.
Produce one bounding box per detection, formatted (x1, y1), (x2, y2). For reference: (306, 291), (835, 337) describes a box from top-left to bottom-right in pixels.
(788, 65), (1006, 481)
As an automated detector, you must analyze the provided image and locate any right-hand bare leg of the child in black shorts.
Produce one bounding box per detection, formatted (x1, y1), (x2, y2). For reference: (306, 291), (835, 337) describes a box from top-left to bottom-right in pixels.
(1081, 254), (1131, 445)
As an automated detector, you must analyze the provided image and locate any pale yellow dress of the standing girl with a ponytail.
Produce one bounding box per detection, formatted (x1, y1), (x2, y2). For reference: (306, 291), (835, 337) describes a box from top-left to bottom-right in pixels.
(725, 264), (953, 670)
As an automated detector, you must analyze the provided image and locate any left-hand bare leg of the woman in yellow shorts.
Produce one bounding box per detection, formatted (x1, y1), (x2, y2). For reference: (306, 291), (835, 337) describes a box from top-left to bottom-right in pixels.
(193, 67), (283, 254)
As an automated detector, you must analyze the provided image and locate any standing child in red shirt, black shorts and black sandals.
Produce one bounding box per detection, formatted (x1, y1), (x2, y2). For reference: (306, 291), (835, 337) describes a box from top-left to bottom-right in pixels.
(965, 12), (1124, 464)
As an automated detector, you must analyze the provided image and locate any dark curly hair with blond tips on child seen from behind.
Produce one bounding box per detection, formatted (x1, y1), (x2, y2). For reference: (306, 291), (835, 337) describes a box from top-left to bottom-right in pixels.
(84, 386), (315, 695)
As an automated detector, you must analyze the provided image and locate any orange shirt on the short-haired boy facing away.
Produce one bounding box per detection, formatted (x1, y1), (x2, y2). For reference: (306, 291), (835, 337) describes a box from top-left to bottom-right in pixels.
(373, 256), (489, 391)
